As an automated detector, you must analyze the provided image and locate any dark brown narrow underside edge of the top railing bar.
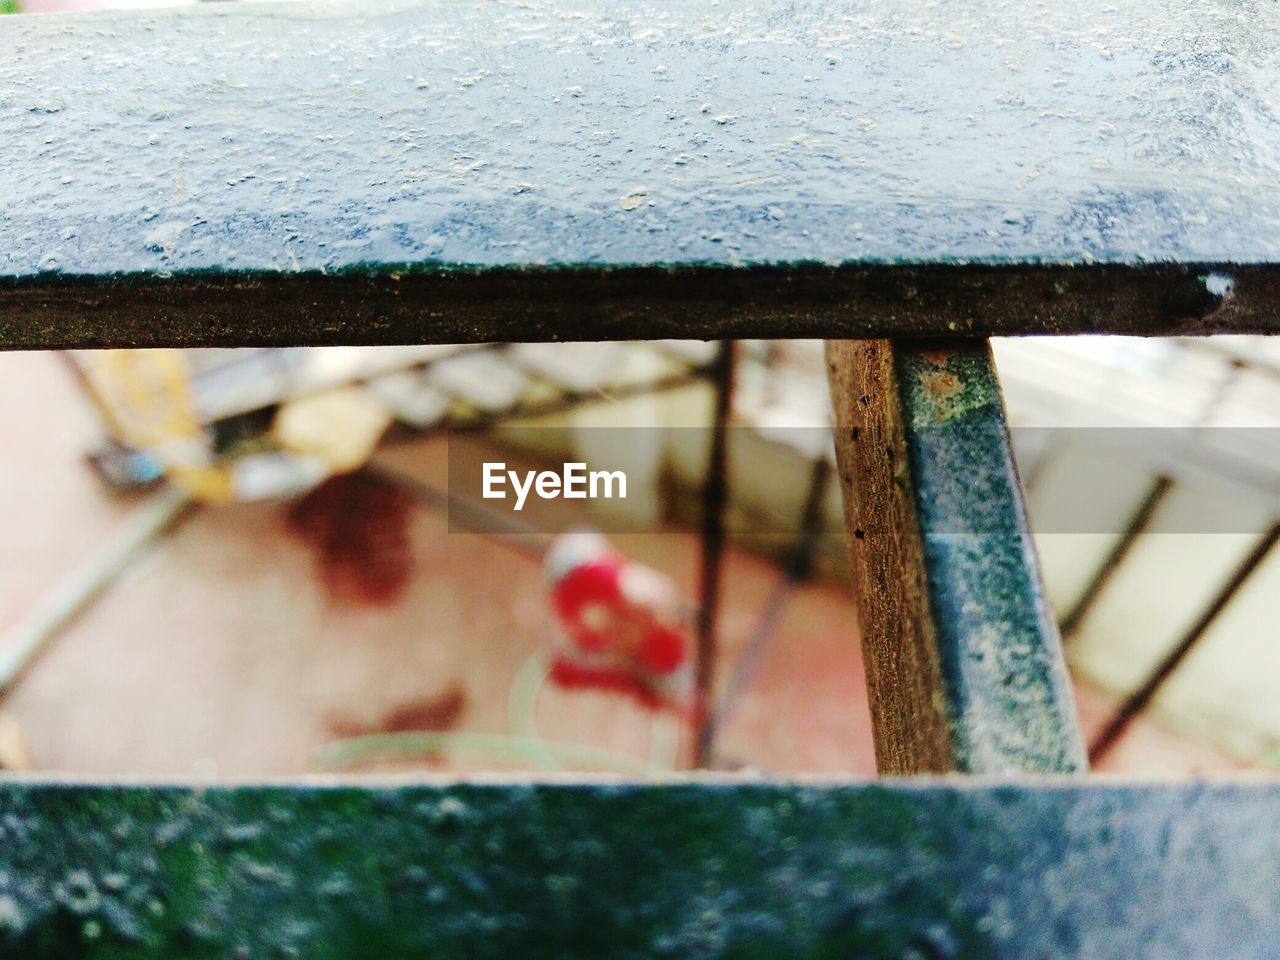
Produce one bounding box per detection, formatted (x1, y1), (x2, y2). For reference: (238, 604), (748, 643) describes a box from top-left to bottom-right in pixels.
(0, 264), (1280, 349)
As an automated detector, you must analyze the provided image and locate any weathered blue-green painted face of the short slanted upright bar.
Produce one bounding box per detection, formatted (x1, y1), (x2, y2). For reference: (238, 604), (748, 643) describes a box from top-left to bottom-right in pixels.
(895, 343), (1088, 773)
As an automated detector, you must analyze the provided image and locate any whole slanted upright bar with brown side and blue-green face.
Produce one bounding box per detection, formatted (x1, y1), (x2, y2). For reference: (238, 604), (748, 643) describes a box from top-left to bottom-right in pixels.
(828, 340), (1087, 773)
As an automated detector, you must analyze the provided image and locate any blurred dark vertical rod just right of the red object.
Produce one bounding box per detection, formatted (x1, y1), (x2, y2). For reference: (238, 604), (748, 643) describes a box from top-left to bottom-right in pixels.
(694, 340), (737, 767)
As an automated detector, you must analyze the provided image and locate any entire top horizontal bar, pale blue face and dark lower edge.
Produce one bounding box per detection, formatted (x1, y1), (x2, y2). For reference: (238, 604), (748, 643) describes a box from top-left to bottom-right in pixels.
(0, 0), (1280, 347)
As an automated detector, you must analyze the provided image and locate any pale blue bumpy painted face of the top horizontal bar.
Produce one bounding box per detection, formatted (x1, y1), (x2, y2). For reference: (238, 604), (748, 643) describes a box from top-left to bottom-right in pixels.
(0, 0), (1280, 275)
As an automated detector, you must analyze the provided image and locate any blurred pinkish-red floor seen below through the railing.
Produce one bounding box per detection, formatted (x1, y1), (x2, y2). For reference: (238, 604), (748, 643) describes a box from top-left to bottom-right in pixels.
(0, 353), (1234, 776)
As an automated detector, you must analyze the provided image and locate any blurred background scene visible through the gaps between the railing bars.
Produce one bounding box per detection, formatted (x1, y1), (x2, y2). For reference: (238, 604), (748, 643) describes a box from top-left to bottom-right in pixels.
(0, 0), (1280, 777)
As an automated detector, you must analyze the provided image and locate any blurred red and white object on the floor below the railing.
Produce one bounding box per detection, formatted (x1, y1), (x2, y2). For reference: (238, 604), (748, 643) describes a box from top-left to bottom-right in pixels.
(547, 532), (692, 713)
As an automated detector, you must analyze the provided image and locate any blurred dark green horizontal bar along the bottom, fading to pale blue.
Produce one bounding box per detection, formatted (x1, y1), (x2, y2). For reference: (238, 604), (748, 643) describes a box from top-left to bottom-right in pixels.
(0, 781), (1280, 960)
